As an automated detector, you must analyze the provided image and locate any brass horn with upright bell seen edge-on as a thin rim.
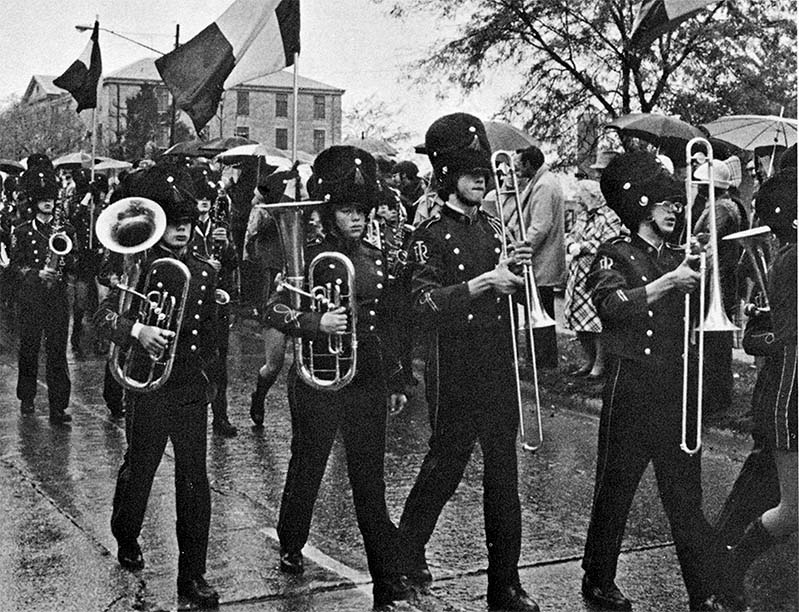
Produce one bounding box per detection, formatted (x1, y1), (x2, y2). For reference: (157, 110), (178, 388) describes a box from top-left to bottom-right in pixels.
(260, 201), (358, 391)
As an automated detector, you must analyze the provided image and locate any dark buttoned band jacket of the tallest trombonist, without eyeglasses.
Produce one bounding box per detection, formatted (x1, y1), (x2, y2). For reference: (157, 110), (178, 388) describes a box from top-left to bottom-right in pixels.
(408, 206), (510, 334)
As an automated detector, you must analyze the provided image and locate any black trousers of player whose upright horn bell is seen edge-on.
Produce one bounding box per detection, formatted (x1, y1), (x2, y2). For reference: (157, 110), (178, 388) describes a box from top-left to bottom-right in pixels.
(277, 366), (396, 581)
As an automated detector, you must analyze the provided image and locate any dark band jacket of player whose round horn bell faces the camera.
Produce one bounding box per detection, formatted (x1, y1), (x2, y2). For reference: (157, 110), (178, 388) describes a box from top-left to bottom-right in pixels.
(95, 246), (217, 403)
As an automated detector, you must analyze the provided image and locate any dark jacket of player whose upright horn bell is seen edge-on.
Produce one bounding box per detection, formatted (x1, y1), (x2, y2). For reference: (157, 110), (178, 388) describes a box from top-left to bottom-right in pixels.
(266, 236), (400, 384)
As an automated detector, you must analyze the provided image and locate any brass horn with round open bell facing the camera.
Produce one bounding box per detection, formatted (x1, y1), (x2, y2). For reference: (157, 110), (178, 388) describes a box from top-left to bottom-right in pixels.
(95, 197), (191, 392)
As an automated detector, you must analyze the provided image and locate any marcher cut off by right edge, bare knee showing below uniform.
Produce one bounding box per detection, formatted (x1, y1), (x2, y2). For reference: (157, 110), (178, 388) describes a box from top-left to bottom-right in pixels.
(726, 162), (798, 610)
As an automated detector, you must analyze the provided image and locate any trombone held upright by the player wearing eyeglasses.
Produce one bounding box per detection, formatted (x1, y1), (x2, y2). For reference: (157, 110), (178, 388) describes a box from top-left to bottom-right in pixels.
(680, 138), (738, 455)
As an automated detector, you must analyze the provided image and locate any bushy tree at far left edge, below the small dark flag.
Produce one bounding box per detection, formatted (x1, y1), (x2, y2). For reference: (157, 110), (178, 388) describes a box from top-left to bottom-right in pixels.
(0, 96), (87, 159)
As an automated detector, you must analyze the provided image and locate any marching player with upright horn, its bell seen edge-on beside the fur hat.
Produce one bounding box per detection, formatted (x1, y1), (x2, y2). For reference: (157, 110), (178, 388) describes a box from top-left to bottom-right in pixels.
(267, 146), (410, 607)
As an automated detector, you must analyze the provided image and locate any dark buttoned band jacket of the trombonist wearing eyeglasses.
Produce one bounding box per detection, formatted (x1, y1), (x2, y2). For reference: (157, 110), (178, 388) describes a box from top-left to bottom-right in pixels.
(588, 234), (696, 368)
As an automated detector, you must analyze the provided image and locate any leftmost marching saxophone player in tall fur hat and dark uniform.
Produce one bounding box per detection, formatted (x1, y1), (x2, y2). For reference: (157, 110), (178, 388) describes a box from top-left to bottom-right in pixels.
(11, 154), (75, 423)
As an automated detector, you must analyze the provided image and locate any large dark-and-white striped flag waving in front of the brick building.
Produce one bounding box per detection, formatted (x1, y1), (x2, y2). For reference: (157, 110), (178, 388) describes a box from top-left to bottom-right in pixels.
(155, 0), (300, 132)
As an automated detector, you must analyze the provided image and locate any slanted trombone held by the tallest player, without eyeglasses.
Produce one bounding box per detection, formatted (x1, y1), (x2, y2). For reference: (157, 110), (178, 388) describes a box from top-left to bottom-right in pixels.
(491, 151), (555, 452)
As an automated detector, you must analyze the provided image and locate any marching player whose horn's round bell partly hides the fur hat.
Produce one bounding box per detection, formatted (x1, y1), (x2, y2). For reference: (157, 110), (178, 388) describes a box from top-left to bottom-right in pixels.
(94, 166), (219, 606)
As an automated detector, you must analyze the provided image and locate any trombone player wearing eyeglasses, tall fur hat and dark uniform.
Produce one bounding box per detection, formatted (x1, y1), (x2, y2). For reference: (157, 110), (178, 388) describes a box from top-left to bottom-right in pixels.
(582, 151), (722, 611)
